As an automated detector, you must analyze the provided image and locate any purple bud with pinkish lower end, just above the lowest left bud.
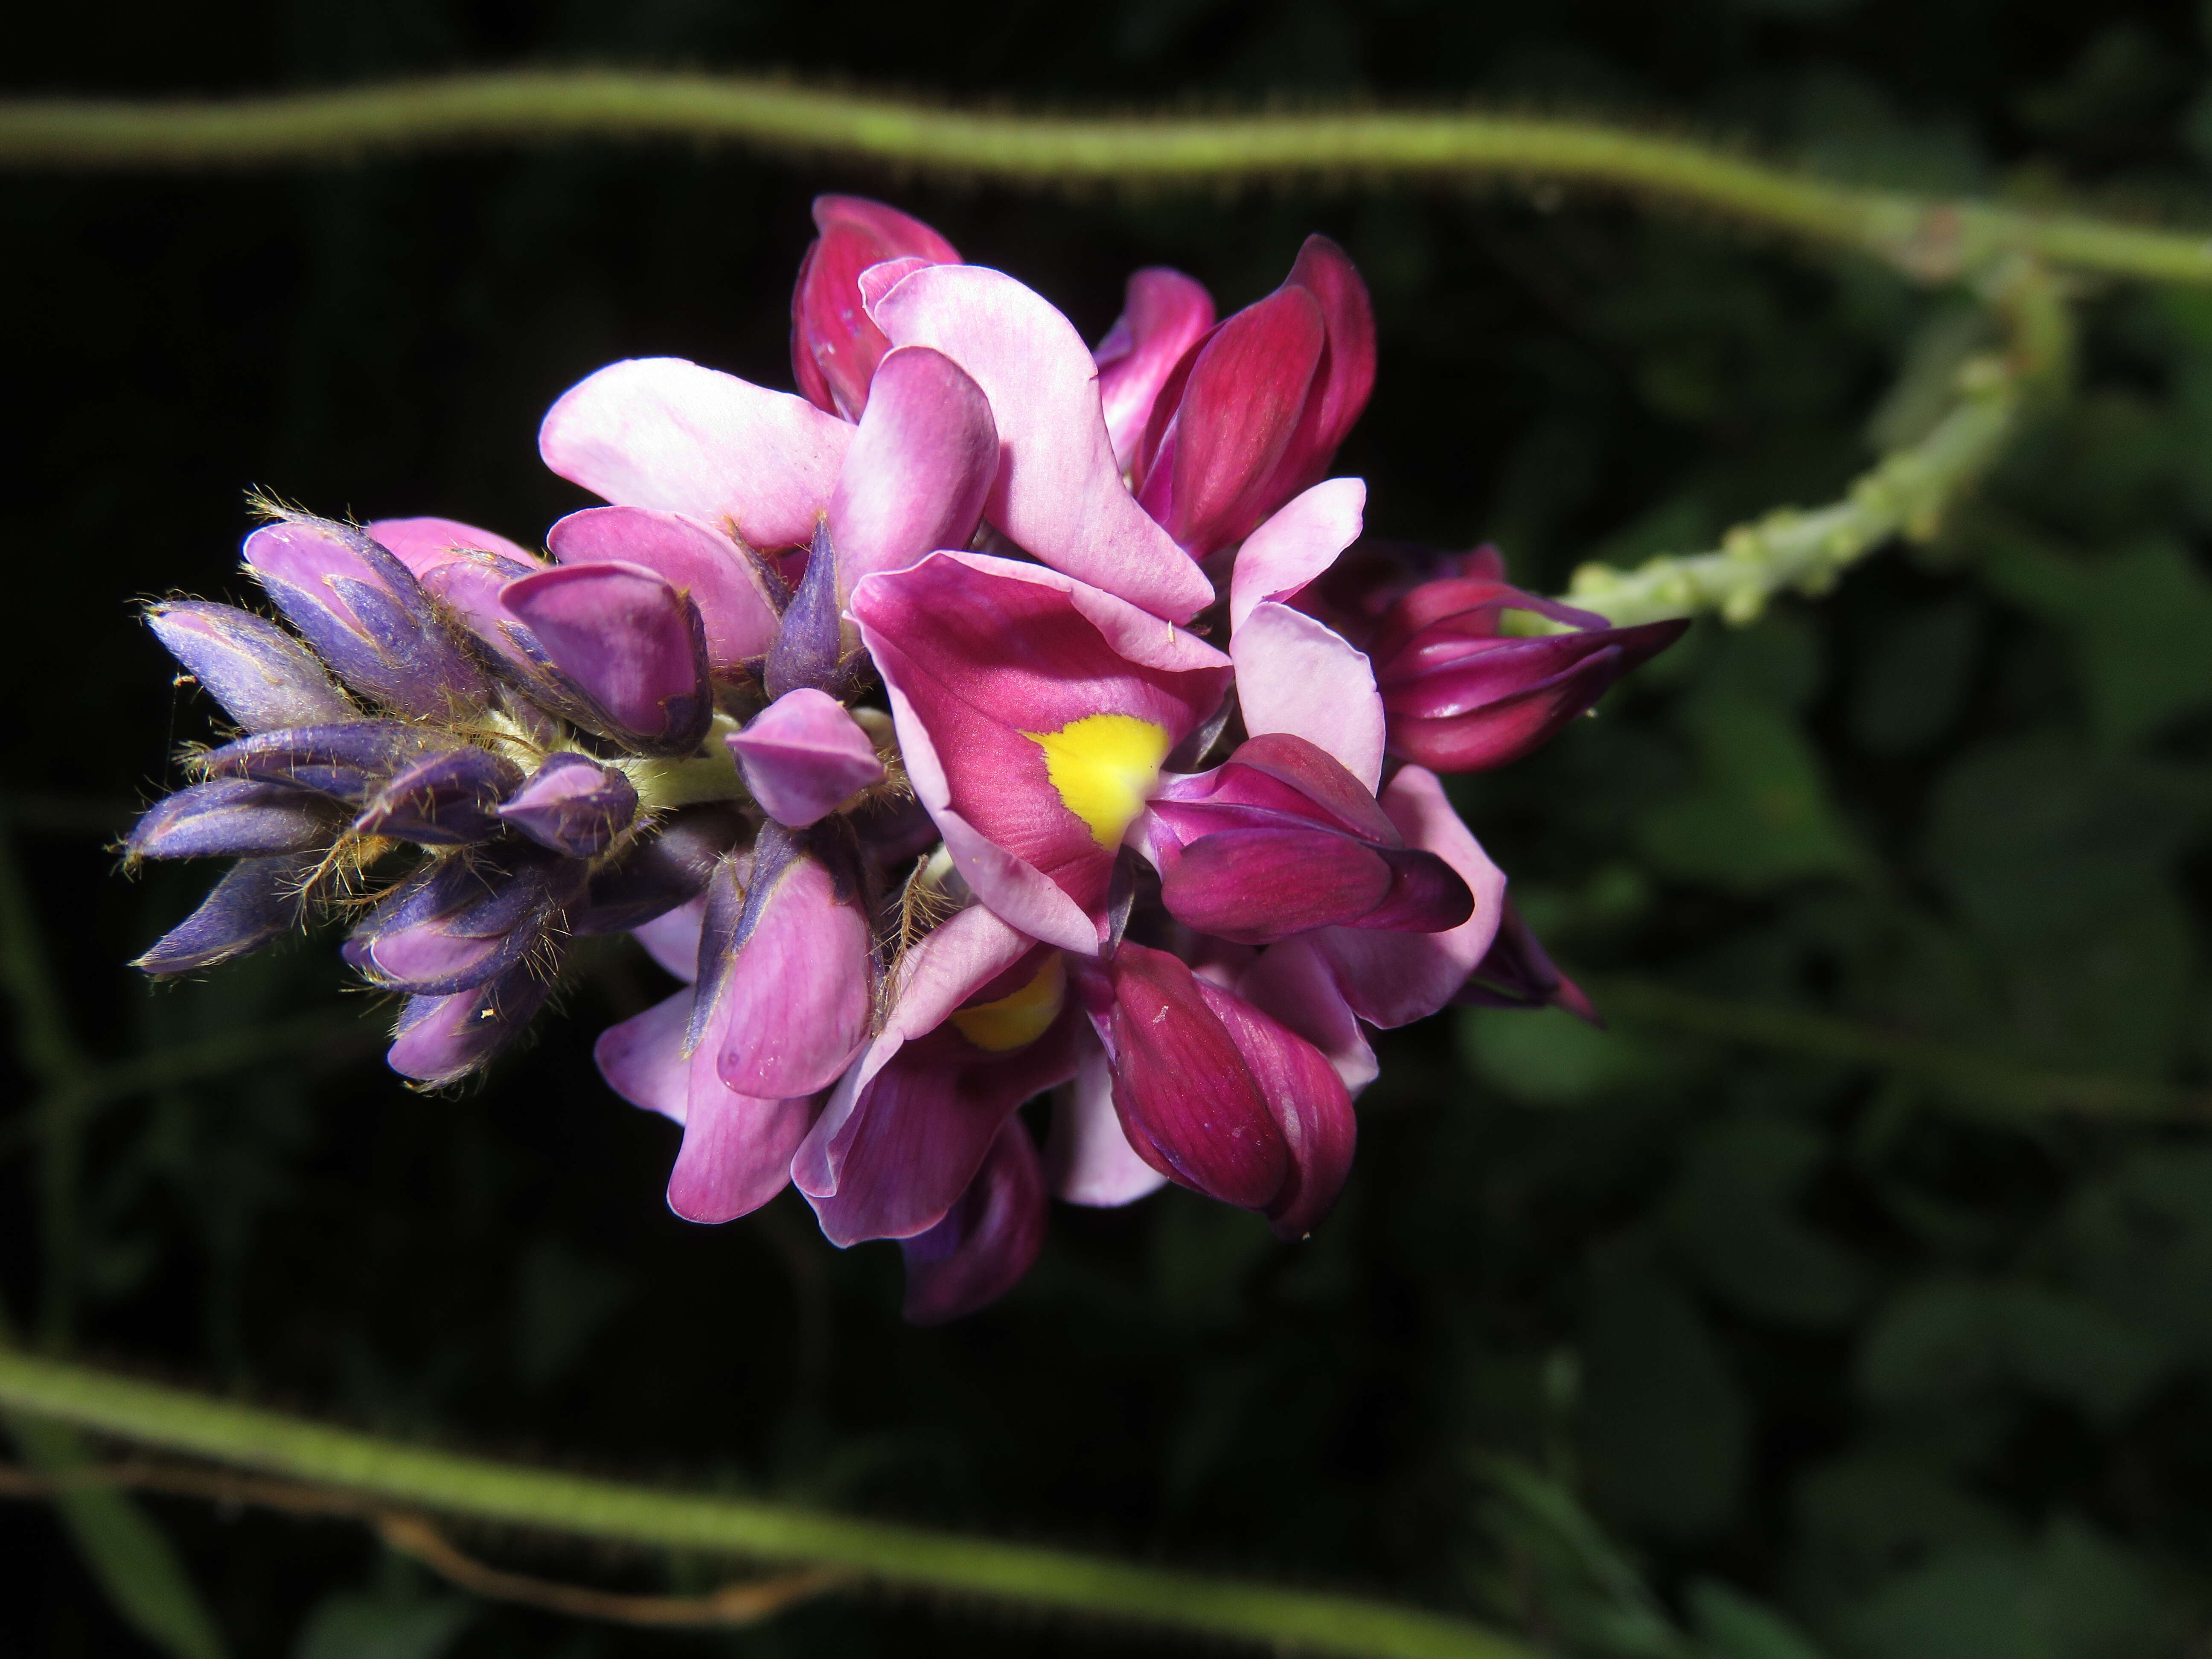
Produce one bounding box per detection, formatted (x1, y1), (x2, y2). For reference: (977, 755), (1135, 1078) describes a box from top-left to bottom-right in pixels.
(343, 850), (584, 995)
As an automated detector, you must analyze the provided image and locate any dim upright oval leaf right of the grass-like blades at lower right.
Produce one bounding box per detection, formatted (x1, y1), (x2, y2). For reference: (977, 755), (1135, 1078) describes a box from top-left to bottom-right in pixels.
(1579, 1241), (1750, 1537)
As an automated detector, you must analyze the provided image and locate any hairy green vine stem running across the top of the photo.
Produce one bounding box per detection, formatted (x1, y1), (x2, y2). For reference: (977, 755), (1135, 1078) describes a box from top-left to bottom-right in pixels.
(0, 71), (2212, 283)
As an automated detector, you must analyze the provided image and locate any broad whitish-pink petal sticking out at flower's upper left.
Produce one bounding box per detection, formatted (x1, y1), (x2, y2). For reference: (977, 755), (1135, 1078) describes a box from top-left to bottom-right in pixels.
(538, 356), (852, 549)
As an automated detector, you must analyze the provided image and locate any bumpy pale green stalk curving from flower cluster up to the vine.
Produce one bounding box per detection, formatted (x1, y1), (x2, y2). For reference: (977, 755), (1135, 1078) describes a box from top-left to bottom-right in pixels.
(1568, 259), (2072, 624)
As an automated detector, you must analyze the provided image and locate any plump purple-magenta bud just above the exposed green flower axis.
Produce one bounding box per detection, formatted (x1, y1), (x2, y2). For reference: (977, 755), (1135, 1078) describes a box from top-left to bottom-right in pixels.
(500, 564), (714, 754)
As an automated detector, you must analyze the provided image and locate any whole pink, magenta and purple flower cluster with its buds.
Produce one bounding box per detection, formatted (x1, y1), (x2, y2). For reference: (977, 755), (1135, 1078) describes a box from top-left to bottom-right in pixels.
(124, 197), (1676, 1321)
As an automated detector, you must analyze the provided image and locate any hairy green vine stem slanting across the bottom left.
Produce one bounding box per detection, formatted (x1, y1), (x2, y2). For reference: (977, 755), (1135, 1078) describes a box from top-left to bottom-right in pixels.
(0, 1347), (1535, 1659)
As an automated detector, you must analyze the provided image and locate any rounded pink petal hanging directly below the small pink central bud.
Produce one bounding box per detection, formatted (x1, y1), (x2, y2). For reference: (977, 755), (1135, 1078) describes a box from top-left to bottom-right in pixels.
(701, 854), (874, 1099)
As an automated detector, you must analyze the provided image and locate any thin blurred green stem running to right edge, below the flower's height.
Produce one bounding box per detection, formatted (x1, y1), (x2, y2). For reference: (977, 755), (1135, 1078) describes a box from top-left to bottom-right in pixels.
(1586, 978), (2212, 1121)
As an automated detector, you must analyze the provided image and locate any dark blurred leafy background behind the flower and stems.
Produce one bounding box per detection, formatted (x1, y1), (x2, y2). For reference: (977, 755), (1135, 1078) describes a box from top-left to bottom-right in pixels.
(0, 0), (2212, 1659)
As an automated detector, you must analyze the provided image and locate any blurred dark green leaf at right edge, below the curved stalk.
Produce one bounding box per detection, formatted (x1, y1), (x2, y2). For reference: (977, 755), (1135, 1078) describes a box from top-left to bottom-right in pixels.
(1984, 538), (2212, 748)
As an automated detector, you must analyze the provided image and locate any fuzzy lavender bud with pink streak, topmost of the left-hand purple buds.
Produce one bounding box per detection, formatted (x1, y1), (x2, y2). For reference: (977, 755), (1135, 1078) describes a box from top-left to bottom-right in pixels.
(245, 518), (489, 719)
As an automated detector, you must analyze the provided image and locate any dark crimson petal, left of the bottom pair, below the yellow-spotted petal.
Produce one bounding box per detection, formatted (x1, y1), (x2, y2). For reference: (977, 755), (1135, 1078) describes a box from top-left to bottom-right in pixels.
(1093, 945), (1289, 1210)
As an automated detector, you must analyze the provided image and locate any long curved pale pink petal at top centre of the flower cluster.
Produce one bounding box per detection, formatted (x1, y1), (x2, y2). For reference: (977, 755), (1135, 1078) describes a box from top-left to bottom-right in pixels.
(876, 265), (1214, 622)
